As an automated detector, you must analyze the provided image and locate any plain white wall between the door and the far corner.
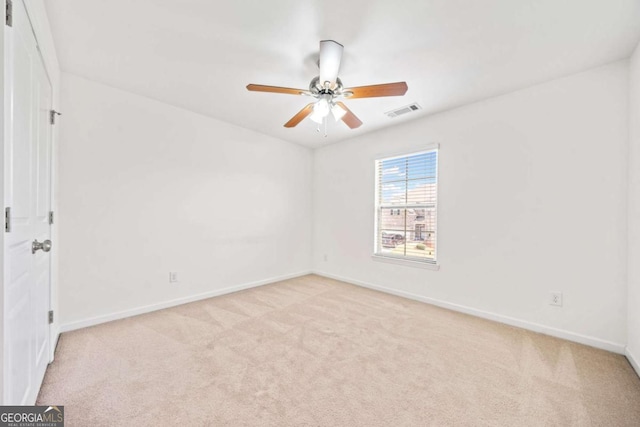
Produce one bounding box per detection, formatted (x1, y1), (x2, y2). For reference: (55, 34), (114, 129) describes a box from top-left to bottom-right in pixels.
(58, 73), (312, 330)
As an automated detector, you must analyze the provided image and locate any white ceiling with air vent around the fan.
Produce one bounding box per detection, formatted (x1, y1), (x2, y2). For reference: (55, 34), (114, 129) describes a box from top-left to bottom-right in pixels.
(46, 0), (640, 147)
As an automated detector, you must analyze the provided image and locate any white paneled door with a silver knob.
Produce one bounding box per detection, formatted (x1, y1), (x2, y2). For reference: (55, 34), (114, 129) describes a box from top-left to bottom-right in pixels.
(4, 0), (52, 405)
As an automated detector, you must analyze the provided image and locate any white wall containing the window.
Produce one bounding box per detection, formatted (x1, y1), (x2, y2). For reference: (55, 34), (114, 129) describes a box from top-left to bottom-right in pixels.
(313, 61), (628, 352)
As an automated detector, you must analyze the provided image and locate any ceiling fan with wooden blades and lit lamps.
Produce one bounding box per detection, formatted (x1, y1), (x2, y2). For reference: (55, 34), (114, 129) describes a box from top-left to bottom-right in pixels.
(247, 40), (407, 136)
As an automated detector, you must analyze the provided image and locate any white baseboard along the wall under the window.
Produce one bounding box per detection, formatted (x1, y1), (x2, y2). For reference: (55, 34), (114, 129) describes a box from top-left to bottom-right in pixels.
(313, 271), (624, 354)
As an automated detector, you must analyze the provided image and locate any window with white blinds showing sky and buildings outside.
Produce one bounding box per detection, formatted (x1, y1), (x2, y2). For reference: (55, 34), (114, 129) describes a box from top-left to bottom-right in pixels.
(375, 149), (438, 264)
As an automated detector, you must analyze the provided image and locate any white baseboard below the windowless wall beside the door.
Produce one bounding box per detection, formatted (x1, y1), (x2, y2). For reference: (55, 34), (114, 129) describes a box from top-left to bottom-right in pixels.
(60, 271), (311, 333)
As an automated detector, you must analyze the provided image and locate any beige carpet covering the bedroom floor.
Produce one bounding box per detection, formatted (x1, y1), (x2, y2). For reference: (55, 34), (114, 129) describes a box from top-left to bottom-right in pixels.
(38, 276), (640, 427)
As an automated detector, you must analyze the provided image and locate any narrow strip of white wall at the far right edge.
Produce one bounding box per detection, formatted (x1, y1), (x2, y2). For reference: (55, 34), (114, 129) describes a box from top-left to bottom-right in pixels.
(627, 41), (640, 374)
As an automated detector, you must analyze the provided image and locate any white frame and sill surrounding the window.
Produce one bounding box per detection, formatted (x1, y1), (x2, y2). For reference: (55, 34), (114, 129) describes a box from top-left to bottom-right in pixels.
(372, 144), (440, 270)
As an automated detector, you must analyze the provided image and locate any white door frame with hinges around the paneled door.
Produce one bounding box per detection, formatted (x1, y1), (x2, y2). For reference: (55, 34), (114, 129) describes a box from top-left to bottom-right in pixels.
(0, 0), (62, 404)
